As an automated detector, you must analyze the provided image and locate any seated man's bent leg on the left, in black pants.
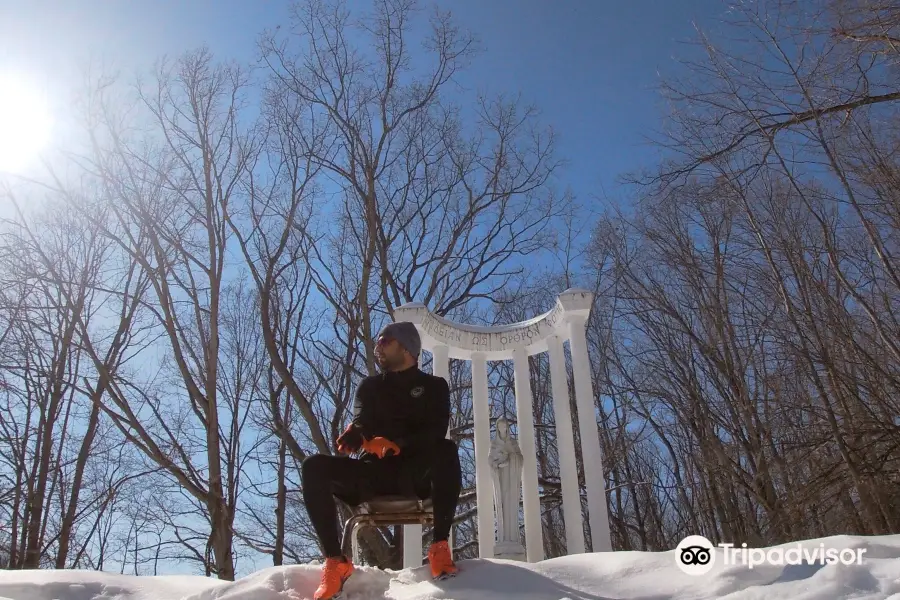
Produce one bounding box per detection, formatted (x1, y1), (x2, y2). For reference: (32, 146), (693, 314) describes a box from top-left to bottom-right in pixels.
(301, 454), (376, 558)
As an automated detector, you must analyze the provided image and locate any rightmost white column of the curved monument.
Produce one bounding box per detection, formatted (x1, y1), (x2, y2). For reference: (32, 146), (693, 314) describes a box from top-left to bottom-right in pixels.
(569, 316), (612, 552)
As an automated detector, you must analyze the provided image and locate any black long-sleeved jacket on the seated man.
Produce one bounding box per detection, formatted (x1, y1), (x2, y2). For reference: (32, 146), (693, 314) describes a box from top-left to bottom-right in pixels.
(353, 365), (450, 458)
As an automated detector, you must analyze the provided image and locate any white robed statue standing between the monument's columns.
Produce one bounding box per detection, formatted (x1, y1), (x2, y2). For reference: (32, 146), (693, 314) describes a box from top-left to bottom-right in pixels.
(488, 417), (525, 561)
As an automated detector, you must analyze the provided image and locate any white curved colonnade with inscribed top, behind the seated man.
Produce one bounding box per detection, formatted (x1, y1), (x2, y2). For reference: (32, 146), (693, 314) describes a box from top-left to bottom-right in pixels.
(394, 289), (612, 567)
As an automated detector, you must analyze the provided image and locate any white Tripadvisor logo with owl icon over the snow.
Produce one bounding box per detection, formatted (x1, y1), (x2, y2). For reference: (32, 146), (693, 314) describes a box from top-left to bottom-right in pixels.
(675, 535), (866, 575)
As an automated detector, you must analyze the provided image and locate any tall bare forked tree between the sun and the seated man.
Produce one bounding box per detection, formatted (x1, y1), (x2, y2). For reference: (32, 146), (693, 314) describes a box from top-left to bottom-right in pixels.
(71, 50), (257, 580)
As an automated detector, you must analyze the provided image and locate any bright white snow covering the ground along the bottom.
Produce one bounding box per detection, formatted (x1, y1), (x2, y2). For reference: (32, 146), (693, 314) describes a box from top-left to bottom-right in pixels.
(0, 535), (900, 600)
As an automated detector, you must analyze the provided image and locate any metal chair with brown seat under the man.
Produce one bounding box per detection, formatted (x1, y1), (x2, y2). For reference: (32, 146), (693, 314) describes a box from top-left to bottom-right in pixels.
(341, 495), (434, 561)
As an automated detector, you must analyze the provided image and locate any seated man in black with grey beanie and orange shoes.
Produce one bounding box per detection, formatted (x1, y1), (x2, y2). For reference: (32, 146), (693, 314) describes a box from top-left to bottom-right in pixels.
(302, 322), (462, 600)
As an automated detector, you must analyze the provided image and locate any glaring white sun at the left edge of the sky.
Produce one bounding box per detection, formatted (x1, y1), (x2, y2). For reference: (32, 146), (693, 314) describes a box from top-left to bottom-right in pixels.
(0, 73), (51, 174)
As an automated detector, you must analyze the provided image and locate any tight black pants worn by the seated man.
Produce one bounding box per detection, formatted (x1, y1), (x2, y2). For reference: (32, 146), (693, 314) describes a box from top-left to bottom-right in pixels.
(302, 440), (462, 558)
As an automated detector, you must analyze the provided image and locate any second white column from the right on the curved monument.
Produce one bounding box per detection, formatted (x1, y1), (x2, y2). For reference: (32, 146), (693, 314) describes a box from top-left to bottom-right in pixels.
(547, 335), (584, 554)
